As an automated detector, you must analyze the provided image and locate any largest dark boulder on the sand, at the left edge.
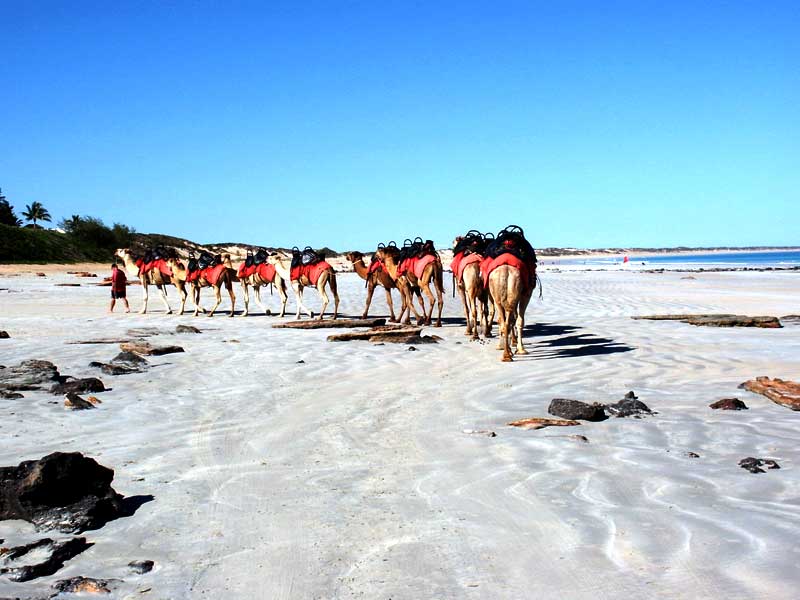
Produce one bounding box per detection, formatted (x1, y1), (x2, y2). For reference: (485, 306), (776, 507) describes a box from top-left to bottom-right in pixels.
(0, 452), (125, 532)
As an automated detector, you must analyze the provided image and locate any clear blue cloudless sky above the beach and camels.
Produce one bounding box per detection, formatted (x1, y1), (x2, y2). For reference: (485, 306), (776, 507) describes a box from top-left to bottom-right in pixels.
(0, 0), (800, 249)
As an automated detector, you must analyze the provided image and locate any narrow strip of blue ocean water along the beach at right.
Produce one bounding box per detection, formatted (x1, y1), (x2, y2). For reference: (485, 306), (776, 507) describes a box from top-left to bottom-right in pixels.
(543, 250), (800, 269)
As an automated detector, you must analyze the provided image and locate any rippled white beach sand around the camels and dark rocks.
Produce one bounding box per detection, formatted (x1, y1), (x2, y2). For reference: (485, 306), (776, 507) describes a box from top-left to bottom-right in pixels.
(0, 272), (800, 599)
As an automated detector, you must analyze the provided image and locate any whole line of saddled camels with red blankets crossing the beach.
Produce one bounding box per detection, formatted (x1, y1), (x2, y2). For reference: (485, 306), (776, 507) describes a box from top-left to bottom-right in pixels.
(115, 225), (538, 361)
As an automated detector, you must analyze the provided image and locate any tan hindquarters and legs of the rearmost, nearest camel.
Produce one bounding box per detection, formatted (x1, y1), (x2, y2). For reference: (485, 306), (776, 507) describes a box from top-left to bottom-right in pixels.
(489, 265), (536, 362)
